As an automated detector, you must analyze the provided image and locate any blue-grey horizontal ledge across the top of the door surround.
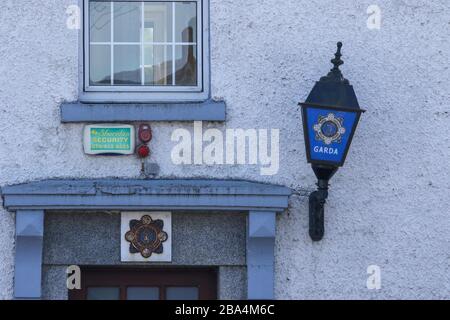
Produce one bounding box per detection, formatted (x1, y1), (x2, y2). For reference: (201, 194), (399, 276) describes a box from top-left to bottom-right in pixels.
(2, 179), (291, 212)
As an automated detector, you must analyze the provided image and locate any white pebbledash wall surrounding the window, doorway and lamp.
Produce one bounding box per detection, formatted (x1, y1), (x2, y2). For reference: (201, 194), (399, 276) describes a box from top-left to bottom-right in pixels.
(0, 0), (450, 299)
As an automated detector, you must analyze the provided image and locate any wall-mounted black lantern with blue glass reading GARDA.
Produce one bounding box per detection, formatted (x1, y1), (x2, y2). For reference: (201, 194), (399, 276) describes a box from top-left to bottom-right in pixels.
(300, 42), (365, 241)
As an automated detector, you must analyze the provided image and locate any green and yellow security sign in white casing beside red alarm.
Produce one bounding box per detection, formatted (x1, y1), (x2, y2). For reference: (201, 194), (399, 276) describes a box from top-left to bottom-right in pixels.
(84, 125), (135, 155)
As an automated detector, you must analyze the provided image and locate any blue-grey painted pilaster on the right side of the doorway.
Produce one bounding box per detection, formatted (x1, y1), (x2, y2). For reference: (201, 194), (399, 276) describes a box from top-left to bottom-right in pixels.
(247, 211), (275, 300)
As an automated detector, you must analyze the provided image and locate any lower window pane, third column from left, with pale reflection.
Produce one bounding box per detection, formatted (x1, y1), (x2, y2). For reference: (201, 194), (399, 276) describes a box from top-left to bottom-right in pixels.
(144, 45), (172, 86)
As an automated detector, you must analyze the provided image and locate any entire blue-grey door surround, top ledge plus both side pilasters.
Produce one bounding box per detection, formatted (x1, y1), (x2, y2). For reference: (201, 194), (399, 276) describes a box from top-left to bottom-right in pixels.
(1, 179), (291, 299)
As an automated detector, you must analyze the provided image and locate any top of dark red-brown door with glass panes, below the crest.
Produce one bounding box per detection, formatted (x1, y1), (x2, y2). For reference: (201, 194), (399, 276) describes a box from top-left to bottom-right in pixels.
(69, 268), (217, 300)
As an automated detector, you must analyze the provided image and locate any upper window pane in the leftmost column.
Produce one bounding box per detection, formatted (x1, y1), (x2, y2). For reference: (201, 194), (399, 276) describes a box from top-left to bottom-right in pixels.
(89, 1), (111, 42)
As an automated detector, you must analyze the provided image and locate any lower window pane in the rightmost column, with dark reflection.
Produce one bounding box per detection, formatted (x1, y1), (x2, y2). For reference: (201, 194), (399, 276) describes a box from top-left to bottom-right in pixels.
(175, 46), (197, 86)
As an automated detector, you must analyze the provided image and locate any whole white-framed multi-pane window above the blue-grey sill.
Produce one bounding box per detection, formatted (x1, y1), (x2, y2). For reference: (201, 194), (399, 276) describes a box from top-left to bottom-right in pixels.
(81, 0), (209, 102)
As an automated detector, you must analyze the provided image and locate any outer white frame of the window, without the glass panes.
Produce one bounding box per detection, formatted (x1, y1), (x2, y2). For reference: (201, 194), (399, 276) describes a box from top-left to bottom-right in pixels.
(79, 0), (210, 103)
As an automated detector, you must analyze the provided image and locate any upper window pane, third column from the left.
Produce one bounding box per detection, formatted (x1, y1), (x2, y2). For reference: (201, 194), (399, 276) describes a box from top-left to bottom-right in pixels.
(144, 2), (172, 42)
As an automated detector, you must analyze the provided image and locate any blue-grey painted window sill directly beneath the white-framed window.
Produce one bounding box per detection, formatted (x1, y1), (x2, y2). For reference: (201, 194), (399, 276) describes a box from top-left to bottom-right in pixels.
(61, 100), (226, 123)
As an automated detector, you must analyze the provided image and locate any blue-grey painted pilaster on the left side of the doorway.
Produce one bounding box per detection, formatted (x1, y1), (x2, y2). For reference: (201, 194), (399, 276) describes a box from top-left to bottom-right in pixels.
(14, 210), (44, 299)
